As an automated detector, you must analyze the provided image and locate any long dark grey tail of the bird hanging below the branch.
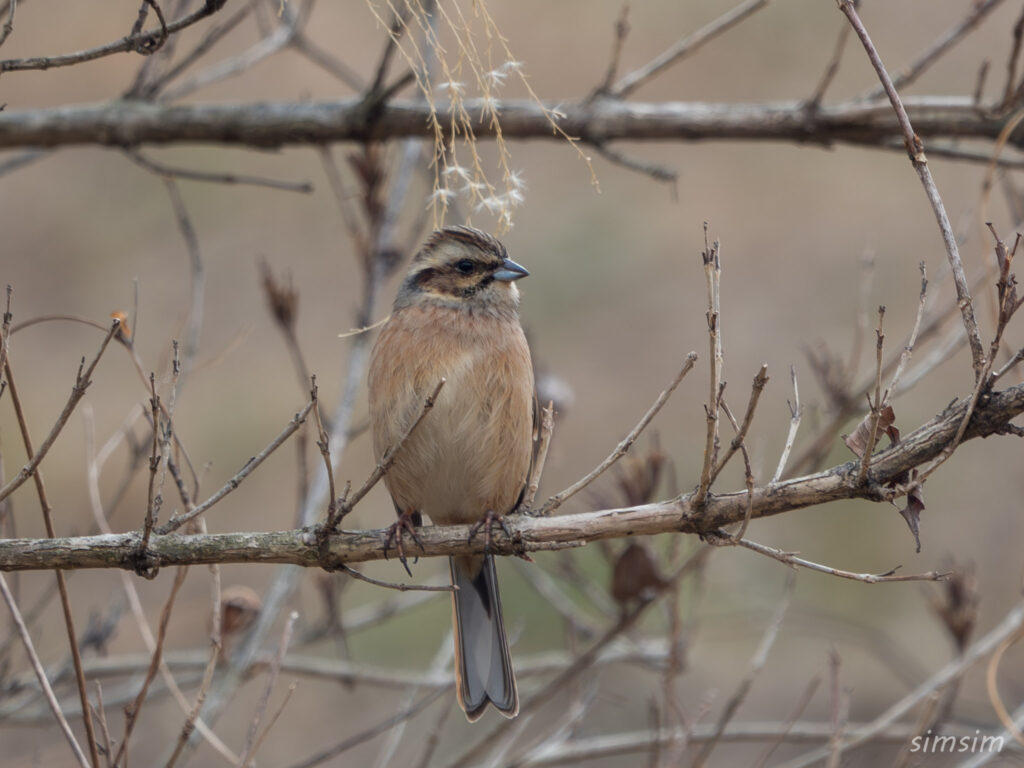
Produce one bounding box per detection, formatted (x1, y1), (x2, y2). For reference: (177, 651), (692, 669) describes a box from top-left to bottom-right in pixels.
(450, 555), (519, 722)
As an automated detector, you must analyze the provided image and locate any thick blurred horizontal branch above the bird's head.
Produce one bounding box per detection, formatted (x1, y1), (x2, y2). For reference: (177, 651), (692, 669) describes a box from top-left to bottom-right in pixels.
(0, 97), (1022, 147)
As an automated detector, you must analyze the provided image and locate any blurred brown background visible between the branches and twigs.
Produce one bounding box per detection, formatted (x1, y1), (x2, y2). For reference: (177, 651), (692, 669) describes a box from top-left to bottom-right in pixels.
(0, 0), (1024, 766)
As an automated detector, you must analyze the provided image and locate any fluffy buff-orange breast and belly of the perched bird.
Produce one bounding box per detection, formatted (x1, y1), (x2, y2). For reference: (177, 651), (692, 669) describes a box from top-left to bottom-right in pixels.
(370, 307), (534, 523)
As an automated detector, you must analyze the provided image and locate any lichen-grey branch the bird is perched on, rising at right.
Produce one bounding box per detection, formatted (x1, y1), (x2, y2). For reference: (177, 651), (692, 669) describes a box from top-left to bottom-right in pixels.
(0, 384), (1024, 570)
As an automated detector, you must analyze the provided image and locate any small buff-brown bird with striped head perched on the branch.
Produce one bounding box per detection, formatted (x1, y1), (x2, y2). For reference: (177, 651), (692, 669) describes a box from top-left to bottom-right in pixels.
(368, 226), (537, 722)
